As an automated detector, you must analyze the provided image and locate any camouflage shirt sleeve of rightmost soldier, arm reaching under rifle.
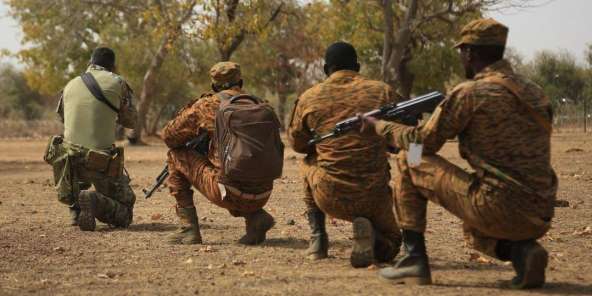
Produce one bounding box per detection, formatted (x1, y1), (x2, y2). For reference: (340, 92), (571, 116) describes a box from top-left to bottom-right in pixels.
(375, 82), (474, 154)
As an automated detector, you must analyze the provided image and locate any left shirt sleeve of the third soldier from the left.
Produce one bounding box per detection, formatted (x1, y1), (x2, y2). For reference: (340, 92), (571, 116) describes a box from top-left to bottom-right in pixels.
(287, 99), (314, 154)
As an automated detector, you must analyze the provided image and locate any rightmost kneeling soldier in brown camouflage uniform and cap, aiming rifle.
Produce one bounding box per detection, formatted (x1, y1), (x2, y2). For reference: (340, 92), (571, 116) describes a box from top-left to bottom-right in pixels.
(358, 19), (557, 288)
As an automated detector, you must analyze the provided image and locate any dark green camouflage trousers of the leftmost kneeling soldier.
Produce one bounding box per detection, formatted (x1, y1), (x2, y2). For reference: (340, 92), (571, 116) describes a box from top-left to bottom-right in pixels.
(74, 167), (136, 227)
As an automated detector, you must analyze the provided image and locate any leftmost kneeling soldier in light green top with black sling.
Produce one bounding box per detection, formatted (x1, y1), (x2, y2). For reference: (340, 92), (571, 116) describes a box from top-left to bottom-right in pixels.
(44, 48), (137, 231)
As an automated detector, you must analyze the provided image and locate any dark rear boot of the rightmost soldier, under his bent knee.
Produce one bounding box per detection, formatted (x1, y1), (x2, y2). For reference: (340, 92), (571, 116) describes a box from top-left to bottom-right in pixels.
(511, 240), (549, 289)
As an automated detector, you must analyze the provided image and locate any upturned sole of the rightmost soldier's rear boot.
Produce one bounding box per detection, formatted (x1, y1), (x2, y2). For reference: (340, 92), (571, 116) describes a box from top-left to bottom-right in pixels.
(512, 245), (549, 289)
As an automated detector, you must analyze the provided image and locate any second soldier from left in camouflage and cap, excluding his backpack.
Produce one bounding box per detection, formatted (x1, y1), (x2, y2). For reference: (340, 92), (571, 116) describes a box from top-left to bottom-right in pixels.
(163, 62), (275, 245)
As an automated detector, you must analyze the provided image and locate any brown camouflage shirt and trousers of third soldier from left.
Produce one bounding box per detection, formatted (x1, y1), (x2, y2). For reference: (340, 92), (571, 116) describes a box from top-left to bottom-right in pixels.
(288, 70), (400, 245)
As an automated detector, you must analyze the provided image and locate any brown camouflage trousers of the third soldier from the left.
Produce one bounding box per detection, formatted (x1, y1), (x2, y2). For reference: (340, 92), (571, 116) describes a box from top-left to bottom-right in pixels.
(302, 162), (401, 249)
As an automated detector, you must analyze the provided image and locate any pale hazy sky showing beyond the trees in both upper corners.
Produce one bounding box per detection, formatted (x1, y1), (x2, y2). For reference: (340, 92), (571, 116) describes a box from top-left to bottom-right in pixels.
(0, 0), (592, 62)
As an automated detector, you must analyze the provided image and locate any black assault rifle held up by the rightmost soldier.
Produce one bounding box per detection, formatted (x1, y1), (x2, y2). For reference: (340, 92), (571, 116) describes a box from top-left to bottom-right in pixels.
(308, 91), (444, 146)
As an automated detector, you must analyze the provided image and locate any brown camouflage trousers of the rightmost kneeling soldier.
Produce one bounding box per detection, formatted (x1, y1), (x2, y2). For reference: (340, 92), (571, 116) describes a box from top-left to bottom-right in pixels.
(394, 151), (551, 257)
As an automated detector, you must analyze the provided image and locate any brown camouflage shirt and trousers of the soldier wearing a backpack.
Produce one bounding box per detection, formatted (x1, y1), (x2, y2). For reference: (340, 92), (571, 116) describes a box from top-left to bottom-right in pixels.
(163, 63), (273, 216)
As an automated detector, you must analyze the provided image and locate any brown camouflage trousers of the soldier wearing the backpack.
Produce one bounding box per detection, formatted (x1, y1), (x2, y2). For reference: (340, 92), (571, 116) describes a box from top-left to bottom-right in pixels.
(167, 148), (273, 217)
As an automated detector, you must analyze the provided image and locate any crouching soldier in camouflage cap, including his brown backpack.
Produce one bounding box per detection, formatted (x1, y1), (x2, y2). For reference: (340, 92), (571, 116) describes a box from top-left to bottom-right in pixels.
(163, 62), (283, 245)
